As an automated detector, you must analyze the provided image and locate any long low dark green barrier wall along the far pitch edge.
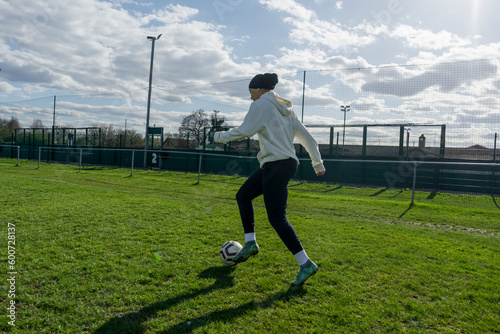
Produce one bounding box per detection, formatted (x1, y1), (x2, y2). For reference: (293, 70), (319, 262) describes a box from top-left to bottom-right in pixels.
(0, 146), (500, 196)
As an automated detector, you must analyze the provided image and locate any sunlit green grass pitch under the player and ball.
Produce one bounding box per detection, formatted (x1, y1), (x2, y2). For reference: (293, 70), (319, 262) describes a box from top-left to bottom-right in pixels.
(0, 159), (500, 333)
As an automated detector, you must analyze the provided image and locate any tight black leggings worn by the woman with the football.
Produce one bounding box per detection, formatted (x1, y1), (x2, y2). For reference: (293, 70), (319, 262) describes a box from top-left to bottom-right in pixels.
(236, 158), (303, 255)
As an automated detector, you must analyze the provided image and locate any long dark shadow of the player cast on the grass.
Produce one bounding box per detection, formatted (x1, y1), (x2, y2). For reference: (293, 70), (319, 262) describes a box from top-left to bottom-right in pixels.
(93, 267), (305, 334)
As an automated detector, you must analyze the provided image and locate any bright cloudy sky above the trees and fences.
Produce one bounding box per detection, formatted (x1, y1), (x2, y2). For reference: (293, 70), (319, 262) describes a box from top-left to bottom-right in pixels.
(0, 0), (500, 146)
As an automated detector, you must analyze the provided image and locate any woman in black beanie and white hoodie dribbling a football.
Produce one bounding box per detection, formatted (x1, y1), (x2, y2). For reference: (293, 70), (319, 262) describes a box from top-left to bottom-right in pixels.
(214, 73), (325, 285)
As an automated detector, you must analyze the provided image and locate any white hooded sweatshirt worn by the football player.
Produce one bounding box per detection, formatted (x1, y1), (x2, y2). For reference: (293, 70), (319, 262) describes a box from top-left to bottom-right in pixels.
(214, 91), (325, 173)
